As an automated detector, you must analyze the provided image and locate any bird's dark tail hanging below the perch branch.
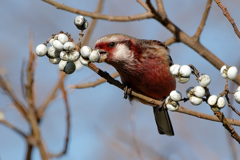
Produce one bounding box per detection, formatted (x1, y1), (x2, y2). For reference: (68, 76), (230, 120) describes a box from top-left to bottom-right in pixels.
(153, 106), (174, 136)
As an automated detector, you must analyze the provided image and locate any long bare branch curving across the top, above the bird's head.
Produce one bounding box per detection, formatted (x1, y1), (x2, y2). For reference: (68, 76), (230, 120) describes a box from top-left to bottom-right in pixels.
(43, 0), (153, 22)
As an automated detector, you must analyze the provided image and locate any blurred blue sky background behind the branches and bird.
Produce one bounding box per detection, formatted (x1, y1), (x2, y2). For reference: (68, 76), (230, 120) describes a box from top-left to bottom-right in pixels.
(0, 0), (240, 160)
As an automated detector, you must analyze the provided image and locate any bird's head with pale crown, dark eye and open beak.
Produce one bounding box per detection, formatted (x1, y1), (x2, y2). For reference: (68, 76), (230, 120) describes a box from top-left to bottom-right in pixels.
(95, 33), (136, 64)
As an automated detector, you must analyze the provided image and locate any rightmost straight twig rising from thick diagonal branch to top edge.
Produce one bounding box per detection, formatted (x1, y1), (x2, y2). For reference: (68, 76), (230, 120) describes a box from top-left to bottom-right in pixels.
(193, 0), (212, 41)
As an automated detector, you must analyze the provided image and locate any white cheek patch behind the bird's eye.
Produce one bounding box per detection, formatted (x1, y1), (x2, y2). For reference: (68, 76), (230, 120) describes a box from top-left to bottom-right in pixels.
(112, 44), (134, 61)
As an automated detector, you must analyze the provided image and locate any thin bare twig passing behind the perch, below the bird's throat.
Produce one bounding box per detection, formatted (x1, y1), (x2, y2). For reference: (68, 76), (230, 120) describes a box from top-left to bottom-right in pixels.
(69, 72), (119, 89)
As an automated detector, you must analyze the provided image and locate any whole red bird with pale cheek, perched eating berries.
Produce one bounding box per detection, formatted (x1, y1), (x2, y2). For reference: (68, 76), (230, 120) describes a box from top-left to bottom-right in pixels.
(95, 34), (176, 136)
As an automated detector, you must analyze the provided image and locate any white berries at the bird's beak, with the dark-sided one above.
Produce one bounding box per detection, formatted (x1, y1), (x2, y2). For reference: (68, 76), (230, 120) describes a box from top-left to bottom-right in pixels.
(36, 15), (100, 74)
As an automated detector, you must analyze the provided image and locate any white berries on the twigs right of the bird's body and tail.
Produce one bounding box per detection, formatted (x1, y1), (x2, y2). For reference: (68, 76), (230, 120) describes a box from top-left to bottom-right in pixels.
(165, 64), (240, 111)
